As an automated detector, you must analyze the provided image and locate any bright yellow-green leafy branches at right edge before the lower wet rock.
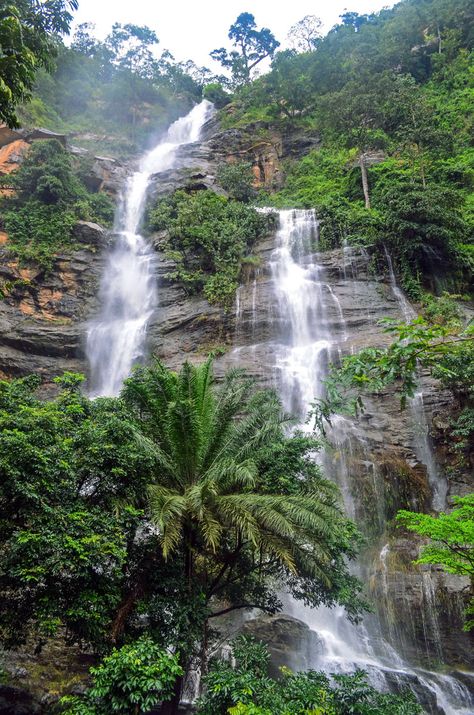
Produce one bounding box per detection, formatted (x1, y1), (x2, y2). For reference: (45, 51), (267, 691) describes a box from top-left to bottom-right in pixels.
(397, 494), (474, 630)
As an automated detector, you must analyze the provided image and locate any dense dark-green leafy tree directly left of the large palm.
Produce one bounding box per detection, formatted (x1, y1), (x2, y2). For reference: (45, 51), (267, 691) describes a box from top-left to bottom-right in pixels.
(0, 374), (154, 651)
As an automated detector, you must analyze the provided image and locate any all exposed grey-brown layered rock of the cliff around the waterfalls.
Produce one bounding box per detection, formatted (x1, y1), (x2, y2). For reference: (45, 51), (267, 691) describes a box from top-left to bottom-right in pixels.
(0, 114), (474, 704)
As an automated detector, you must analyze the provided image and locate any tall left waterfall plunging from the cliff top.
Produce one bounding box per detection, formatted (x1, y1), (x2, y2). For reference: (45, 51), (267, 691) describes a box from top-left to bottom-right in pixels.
(86, 100), (213, 397)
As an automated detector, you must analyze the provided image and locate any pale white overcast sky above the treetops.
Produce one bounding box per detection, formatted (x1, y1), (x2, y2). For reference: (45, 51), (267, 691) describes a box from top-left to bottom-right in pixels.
(71, 0), (394, 69)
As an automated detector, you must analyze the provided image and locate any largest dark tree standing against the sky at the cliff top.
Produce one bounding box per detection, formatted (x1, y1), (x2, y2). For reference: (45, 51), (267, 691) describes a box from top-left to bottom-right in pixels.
(211, 12), (280, 86)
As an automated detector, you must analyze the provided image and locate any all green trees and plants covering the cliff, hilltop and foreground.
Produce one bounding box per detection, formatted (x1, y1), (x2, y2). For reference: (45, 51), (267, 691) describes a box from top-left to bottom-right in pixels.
(0, 0), (474, 715)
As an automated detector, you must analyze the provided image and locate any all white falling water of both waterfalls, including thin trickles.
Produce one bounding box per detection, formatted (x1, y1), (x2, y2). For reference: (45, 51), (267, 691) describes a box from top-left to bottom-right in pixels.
(86, 101), (474, 715)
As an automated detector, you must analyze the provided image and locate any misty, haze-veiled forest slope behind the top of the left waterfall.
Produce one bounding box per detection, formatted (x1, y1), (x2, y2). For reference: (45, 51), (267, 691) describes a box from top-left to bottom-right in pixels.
(19, 23), (219, 157)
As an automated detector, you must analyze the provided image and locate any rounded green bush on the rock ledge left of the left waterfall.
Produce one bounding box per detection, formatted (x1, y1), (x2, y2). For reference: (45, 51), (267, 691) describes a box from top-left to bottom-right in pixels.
(2, 140), (114, 267)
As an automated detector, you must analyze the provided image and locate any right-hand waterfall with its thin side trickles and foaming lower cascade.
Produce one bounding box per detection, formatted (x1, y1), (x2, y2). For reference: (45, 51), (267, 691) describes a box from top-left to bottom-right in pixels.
(235, 210), (474, 715)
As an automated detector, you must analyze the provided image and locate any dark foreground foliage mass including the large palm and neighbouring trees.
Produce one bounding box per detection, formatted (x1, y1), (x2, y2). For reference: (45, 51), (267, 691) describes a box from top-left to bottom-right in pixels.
(0, 361), (367, 712)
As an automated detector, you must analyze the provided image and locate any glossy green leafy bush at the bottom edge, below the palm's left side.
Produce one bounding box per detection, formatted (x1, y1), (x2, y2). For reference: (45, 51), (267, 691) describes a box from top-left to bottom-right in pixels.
(61, 637), (183, 715)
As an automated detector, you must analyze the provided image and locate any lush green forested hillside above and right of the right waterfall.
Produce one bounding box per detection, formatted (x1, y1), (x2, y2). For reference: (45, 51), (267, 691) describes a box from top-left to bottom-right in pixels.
(221, 0), (474, 299)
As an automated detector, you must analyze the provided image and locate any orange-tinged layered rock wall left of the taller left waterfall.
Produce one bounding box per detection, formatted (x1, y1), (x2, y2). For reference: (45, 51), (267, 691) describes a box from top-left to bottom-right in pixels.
(0, 245), (104, 382)
